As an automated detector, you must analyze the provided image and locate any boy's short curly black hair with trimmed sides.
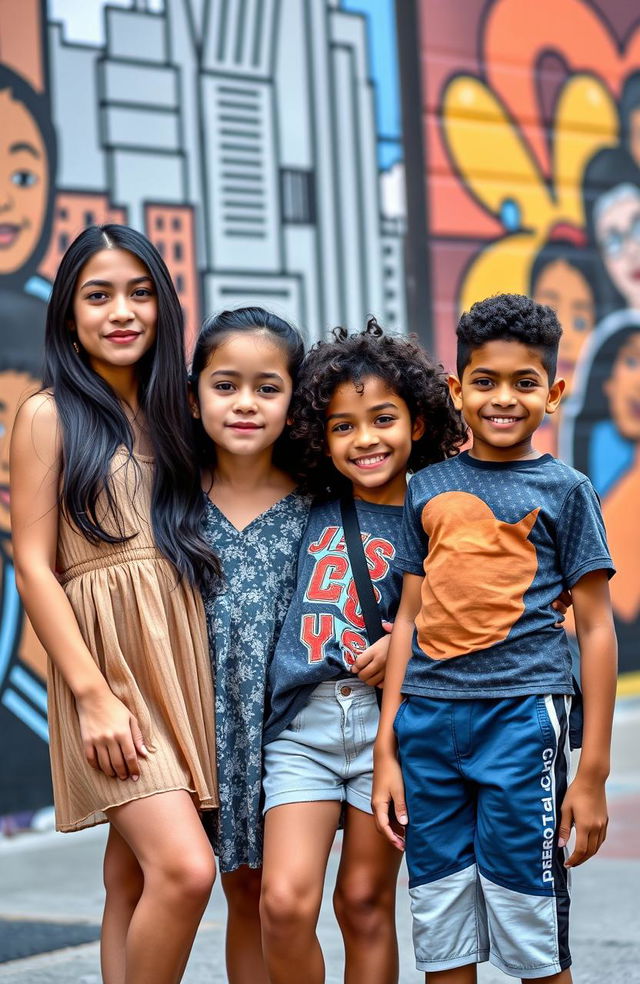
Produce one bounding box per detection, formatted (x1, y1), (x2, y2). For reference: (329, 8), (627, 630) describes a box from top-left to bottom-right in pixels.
(456, 294), (562, 383)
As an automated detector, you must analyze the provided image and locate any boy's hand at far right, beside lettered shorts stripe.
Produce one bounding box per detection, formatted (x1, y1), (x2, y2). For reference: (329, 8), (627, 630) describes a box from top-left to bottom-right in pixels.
(558, 775), (609, 868)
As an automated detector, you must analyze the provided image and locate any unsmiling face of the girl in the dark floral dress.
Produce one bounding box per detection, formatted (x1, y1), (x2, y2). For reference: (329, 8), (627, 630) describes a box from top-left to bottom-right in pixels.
(194, 330), (293, 457)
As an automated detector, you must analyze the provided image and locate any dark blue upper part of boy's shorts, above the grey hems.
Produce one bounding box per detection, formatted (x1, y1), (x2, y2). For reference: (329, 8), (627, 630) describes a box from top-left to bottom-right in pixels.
(395, 696), (568, 897)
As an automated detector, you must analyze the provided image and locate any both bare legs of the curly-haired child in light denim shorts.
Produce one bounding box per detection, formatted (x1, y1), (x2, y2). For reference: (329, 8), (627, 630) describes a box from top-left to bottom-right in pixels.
(260, 801), (401, 984)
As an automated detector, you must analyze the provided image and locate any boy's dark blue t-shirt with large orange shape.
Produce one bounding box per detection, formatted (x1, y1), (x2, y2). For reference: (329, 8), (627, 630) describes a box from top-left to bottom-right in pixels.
(396, 452), (614, 698)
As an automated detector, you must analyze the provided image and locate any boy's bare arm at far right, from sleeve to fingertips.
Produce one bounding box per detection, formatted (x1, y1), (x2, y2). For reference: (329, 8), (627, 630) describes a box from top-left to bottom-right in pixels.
(559, 570), (617, 868)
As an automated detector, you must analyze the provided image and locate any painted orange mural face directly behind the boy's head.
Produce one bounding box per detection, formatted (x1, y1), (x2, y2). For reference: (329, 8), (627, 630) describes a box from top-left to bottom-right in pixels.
(533, 260), (596, 393)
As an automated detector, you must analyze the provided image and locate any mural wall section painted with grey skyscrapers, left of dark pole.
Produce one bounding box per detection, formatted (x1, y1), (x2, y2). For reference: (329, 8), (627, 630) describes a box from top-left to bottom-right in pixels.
(0, 0), (406, 816)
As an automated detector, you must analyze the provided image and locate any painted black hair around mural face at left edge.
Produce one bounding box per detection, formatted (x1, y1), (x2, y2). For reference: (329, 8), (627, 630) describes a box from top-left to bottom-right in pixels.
(0, 65), (57, 290)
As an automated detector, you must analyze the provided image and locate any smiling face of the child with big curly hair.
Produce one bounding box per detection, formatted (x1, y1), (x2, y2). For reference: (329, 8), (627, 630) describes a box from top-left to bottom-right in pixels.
(325, 376), (424, 505)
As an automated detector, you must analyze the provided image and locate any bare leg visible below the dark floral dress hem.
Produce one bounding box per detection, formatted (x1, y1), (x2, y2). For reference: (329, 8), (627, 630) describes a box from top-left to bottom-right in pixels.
(220, 865), (268, 984)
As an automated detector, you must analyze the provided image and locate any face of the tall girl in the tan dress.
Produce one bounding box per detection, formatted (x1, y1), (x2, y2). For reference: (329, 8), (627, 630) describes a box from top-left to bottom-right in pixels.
(69, 249), (158, 379)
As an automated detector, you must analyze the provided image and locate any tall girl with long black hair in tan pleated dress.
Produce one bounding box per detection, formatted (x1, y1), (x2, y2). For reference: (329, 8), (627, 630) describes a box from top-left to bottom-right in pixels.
(11, 225), (219, 984)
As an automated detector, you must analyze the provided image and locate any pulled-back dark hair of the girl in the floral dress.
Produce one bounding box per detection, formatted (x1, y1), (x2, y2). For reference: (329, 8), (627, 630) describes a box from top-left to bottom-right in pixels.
(190, 307), (304, 477)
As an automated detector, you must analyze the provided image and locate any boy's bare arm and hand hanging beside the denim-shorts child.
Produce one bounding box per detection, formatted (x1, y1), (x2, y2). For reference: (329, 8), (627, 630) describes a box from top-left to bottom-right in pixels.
(371, 574), (423, 850)
